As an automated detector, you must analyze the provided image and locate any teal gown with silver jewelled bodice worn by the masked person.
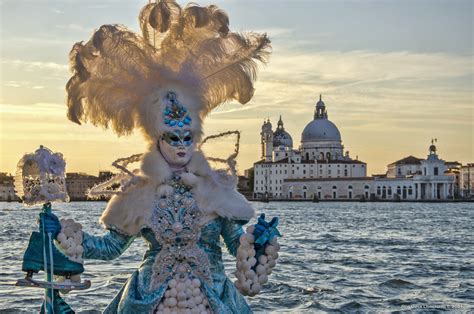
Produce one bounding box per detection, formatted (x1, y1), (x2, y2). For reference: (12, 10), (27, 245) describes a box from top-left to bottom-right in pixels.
(82, 177), (252, 313)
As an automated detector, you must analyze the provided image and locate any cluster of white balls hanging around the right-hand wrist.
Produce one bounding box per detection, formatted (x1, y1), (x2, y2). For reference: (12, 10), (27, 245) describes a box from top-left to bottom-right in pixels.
(235, 226), (280, 297)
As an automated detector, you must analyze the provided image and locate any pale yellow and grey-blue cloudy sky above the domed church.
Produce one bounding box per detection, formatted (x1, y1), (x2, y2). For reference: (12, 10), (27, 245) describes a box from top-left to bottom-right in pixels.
(0, 0), (474, 175)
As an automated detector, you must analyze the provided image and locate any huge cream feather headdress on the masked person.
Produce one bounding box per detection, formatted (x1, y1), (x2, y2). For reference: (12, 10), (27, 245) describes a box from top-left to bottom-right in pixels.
(66, 0), (270, 141)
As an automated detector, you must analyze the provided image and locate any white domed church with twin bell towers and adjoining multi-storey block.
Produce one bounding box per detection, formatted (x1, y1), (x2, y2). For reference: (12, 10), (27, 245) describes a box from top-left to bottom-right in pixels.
(254, 96), (372, 199)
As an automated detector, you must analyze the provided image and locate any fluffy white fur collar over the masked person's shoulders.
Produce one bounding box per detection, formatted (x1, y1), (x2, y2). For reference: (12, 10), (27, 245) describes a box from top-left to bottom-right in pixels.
(100, 146), (254, 235)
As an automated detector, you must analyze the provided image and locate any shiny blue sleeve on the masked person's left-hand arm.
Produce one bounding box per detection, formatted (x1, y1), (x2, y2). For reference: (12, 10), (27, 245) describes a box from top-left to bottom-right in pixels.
(82, 230), (135, 260)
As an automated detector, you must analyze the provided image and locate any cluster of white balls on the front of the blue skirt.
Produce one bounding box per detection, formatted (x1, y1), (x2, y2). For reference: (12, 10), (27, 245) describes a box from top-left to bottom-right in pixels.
(155, 275), (211, 314)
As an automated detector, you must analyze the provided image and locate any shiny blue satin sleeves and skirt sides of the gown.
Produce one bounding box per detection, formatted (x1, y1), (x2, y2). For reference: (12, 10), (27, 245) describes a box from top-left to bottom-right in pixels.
(83, 217), (252, 314)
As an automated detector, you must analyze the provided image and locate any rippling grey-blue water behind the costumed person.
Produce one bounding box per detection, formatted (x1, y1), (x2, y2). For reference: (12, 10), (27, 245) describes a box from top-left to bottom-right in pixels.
(0, 202), (474, 313)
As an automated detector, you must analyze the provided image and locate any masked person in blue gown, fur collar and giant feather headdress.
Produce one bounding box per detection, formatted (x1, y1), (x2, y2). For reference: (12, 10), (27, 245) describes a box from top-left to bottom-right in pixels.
(40, 0), (279, 313)
